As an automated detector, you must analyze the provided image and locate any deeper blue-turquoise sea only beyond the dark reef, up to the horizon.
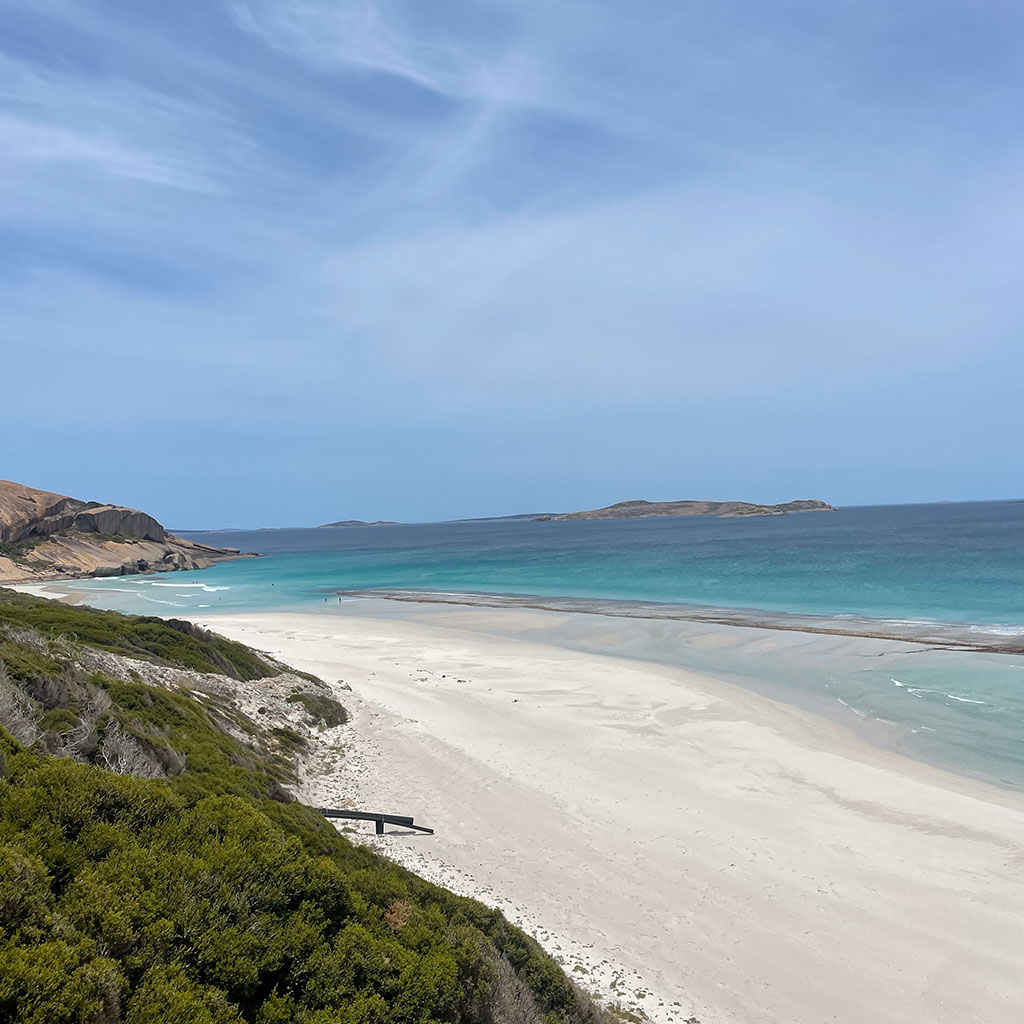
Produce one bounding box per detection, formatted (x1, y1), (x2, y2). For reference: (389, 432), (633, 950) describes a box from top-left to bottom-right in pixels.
(103, 502), (1024, 626)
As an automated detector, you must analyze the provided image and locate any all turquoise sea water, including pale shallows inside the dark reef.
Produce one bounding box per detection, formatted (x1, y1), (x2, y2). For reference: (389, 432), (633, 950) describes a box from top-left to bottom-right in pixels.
(44, 502), (1024, 785)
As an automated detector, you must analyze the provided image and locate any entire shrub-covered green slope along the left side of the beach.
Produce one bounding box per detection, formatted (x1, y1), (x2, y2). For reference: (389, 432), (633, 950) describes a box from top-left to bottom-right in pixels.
(0, 591), (603, 1024)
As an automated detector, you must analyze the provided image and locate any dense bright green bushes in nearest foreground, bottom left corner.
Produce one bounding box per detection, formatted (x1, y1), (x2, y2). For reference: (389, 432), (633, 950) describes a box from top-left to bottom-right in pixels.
(0, 733), (592, 1024)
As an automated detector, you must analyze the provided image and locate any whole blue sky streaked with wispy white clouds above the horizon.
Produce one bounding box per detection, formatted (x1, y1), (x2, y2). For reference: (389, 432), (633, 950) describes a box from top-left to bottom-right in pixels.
(0, 0), (1024, 527)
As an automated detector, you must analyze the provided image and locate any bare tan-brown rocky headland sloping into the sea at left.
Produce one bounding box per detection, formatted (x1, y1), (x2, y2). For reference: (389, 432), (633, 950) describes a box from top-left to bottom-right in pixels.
(0, 480), (254, 583)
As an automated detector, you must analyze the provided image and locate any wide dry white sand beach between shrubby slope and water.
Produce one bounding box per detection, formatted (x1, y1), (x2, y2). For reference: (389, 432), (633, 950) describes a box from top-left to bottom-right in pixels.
(192, 609), (1024, 1024)
